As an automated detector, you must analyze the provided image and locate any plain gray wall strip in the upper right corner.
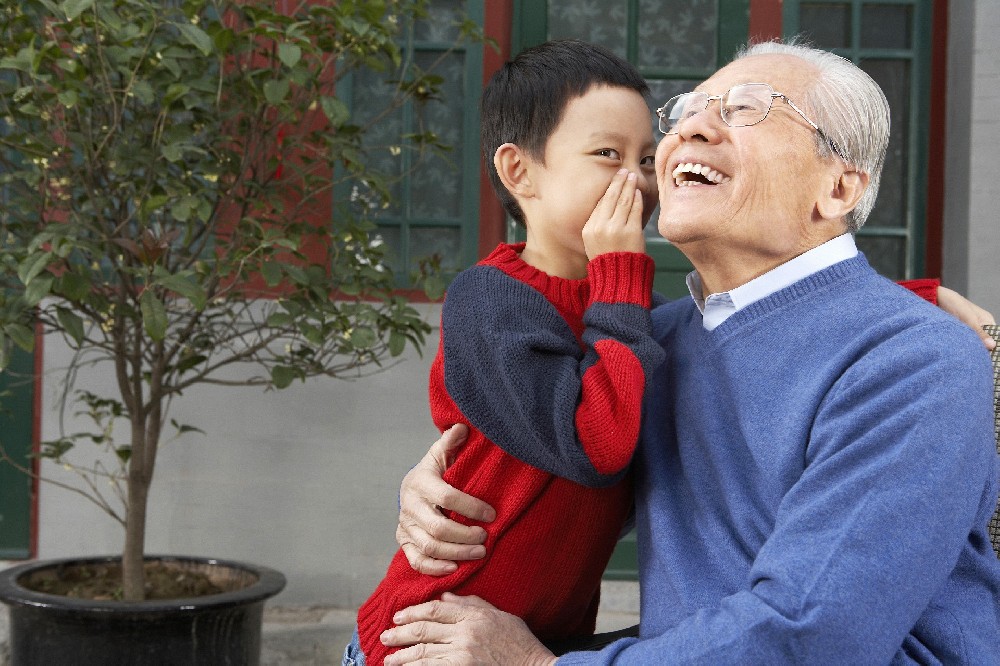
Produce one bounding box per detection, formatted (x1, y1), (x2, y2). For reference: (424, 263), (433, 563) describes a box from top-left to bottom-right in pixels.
(942, 0), (1000, 317)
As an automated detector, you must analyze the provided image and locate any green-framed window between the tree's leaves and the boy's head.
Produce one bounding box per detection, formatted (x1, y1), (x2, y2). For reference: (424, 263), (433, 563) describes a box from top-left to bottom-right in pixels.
(337, 0), (484, 289)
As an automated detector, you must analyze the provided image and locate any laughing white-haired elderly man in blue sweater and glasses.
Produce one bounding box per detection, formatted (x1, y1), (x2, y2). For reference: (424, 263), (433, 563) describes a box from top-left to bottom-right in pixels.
(383, 43), (1000, 664)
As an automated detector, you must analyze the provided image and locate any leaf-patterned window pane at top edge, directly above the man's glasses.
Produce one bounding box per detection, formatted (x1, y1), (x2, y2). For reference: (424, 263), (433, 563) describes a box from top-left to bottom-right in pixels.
(637, 0), (719, 69)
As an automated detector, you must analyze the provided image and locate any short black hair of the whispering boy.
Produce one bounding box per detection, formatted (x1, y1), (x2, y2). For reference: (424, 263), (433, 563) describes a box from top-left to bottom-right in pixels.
(480, 39), (649, 224)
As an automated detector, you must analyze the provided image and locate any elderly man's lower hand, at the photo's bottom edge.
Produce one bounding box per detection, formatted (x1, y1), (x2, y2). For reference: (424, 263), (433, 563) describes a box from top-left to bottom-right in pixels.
(382, 592), (556, 666)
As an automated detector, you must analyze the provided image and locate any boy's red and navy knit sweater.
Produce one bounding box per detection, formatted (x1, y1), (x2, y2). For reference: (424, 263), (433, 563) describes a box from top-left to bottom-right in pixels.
(358, 245), (664, 664)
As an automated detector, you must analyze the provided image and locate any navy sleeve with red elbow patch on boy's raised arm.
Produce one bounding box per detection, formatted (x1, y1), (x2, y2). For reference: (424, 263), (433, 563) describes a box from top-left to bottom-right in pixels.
(441, 266), (663, 487)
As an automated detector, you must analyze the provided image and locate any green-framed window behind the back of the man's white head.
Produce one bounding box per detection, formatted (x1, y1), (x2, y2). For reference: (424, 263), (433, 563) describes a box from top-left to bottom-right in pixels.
(782, 0), (933, 280)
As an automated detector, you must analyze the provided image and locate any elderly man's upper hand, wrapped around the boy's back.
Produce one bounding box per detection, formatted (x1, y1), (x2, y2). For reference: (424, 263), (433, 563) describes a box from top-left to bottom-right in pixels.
(396, 424), (496, 576)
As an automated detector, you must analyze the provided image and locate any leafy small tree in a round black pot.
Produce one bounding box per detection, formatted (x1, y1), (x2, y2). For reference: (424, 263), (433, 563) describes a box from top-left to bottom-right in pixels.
(0, 0), (475, 664)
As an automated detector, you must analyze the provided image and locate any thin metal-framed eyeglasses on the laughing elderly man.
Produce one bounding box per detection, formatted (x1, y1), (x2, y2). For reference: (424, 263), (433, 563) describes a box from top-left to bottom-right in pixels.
(656, 83), (849, 161)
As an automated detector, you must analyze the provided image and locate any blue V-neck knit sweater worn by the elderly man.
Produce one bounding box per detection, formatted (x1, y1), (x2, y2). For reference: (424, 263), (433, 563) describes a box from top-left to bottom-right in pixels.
(560, 255), (1000, 666)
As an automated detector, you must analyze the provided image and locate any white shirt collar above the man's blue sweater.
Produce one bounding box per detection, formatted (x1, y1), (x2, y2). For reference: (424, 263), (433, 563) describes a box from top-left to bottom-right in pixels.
(686, 233), (858, 331)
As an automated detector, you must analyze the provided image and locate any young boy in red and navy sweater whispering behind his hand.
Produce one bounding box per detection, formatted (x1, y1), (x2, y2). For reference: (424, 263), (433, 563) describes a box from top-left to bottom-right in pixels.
(345, 40), (663, 664)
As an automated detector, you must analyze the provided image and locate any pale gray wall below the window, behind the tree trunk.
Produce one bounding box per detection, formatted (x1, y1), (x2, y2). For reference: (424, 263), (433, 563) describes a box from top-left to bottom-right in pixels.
(38, 306), (440, 608)
